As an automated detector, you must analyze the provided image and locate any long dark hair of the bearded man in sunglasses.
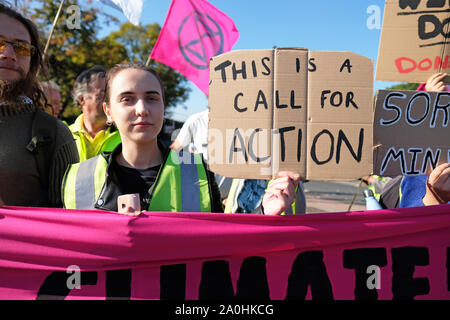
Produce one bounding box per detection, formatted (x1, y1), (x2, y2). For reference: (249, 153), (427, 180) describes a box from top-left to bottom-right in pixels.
(0, 4), (48, 110)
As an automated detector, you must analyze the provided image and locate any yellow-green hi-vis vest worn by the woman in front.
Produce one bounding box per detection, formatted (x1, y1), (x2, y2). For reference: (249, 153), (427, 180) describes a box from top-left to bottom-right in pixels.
(62, 150), (211, 212)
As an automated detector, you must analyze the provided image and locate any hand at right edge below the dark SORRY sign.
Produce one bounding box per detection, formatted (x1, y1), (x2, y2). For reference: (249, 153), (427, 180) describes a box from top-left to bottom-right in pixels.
(422, 163), (450, 206)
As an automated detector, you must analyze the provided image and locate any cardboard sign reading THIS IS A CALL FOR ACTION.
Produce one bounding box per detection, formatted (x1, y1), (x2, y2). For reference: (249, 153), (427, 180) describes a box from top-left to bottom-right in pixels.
(208, 48), (373, 180)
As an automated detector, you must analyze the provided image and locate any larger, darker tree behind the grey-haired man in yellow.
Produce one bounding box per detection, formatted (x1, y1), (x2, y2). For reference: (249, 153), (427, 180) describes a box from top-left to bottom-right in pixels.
(30, 0), (127, 119)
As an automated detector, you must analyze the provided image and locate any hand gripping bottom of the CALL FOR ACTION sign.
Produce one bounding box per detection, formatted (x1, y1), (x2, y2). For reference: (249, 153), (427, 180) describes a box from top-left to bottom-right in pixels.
(262, 171), (301, 215)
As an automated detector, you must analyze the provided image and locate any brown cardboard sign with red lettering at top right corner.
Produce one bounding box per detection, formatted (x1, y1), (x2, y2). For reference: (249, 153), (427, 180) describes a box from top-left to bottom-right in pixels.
(375, 0), (450, 83)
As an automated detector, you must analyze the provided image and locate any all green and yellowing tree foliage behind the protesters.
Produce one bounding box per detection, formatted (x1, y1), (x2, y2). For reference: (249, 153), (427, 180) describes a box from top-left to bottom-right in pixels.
(21, 0), (189, 119)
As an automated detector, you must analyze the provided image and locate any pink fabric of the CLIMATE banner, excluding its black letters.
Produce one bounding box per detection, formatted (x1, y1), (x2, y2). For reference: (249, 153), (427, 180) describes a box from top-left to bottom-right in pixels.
(0, 205), (450, 299)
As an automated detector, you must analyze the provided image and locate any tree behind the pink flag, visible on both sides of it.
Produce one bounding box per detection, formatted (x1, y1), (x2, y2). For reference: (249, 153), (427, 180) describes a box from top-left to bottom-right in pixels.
(107, 22), (190, 114)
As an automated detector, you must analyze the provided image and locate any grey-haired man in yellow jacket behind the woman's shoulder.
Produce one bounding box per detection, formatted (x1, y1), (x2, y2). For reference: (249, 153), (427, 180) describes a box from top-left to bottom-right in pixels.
(69, 66), (121, 161)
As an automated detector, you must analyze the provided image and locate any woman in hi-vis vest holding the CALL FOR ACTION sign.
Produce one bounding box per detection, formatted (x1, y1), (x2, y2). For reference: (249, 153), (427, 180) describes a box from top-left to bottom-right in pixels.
(62, 64), (300, 214)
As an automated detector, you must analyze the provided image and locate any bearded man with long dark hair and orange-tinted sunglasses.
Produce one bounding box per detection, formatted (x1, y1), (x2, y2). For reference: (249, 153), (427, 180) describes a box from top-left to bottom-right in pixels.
(0, 4), (78, 207)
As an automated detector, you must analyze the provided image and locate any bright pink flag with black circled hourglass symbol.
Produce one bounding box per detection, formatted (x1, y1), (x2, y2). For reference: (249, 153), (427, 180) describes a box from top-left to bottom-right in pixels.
(150, 0), (239, 95)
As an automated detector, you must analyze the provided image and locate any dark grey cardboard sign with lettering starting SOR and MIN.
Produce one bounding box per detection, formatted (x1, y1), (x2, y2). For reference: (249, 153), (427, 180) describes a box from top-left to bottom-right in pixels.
(373, 90), (450, 176)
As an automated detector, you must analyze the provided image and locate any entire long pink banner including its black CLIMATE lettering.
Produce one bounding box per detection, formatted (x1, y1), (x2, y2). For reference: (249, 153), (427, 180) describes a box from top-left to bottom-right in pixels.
(0, 205), (450, 300)
